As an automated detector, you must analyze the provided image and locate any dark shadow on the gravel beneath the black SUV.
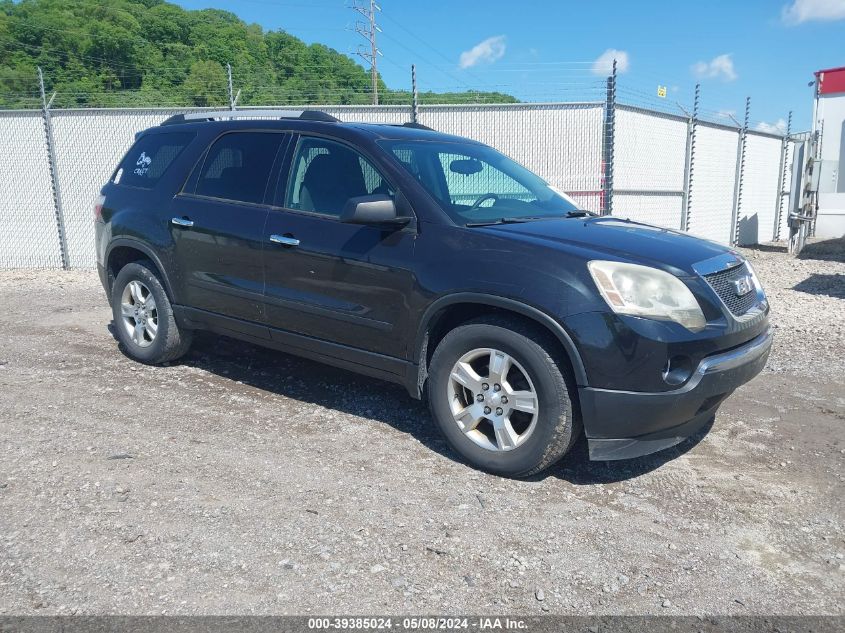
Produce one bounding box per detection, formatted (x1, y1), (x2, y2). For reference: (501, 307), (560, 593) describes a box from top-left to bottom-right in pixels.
(117, 323), (713, 486)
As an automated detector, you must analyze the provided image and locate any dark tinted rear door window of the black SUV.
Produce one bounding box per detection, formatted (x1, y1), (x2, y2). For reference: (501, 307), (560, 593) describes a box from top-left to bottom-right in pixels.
(196, 132), (282, 203)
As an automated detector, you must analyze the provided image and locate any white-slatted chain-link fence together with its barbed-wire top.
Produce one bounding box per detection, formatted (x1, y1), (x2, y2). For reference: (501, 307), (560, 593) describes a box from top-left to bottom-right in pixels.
(0, 61), (793, 267)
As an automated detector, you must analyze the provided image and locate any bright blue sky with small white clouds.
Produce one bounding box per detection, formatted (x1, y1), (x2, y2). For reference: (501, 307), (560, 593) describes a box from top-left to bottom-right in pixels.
(179, 0), (845, 129)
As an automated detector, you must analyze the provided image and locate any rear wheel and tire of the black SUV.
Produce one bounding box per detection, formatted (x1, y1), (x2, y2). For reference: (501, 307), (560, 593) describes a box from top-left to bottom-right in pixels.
(111, 260), (193, 365)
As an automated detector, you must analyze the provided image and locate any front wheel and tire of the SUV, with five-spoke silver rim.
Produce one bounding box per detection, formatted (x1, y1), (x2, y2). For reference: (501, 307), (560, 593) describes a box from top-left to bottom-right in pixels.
(427, 316), (581, 477)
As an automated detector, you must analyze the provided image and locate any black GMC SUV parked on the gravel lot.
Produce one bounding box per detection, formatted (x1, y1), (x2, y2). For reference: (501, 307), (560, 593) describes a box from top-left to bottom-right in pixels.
(96, 111), (772, 476)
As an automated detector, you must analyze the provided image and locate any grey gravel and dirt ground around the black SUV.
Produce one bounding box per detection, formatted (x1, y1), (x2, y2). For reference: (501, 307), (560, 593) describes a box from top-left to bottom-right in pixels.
(0, 237), (845, 615)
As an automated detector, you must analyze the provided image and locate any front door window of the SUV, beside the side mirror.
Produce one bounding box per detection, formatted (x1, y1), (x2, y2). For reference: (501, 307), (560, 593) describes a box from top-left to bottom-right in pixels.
(285, 138), (393, 216)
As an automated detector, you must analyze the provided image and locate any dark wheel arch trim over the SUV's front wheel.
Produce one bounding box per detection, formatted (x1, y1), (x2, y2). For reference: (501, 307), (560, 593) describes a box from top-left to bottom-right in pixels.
(413, 292), (587, 397)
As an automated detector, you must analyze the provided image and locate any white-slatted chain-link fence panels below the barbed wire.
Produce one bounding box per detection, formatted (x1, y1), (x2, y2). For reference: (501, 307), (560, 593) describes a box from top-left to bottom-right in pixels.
(0, 99), (792, 268)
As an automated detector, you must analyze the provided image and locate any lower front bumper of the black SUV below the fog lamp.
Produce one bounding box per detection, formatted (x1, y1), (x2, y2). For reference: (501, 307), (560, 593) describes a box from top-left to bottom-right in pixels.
(578, 328), (773, 460)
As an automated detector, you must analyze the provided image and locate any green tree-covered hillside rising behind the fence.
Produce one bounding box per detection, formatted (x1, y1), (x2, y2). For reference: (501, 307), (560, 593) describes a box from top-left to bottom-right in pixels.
(0, 0), (516, 108)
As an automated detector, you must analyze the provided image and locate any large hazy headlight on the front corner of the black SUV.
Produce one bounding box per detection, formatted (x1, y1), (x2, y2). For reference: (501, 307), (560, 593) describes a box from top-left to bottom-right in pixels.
(587, 261), (706, 332)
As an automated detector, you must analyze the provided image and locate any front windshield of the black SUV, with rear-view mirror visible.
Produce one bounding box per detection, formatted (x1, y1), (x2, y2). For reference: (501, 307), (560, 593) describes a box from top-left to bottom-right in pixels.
(381, 141), (577, 225)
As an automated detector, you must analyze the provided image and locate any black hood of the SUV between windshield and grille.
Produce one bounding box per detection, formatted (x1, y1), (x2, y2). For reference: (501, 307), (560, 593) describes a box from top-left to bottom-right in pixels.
(484, 216), (743, 275)
